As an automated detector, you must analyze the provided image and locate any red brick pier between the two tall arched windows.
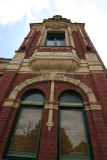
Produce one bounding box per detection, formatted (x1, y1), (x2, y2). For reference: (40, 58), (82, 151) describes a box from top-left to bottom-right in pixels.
(39, 109), (58, 160)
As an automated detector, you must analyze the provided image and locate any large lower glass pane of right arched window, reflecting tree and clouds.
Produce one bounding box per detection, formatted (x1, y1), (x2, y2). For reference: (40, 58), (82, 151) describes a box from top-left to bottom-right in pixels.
(60, 110), (88, 155)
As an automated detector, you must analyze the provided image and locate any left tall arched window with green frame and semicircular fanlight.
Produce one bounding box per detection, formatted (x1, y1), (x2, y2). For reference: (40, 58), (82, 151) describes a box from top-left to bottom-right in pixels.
(6, 90), (45, 160)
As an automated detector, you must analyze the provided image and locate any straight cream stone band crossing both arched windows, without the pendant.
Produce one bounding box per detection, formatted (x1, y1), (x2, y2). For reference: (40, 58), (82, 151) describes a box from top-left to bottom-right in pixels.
(3, 98), (102, 110)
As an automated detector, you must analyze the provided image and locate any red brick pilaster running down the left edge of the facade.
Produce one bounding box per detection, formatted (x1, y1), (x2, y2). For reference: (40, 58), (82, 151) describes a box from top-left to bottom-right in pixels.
(0, 72), (16, 157)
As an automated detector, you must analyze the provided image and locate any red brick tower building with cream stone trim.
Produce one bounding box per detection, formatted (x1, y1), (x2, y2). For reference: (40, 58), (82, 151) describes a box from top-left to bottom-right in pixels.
(0, 15), (107, 160)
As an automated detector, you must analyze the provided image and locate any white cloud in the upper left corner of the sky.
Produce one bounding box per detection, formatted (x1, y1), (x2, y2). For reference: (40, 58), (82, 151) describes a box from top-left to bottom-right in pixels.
(0, 0), (50, 25)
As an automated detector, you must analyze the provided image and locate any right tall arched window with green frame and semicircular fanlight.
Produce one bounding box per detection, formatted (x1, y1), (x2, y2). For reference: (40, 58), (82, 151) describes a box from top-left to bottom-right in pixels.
(58, 90), (91, 160)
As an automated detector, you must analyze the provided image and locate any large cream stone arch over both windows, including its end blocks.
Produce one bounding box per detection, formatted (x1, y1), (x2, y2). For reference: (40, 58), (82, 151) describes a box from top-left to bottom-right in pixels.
(3, 74), (102, 110)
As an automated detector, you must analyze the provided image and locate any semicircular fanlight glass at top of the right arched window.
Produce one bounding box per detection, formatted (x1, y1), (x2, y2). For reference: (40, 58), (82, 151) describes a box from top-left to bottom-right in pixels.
(60, 94), (81, 103)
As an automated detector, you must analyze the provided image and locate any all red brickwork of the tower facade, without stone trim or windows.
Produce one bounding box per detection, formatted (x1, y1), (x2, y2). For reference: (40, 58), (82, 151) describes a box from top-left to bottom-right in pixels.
(0, 26), (107, 160)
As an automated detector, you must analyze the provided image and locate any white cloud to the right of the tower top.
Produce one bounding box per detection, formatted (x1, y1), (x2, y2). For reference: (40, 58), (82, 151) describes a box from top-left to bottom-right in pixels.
(55, 0), (107, 66)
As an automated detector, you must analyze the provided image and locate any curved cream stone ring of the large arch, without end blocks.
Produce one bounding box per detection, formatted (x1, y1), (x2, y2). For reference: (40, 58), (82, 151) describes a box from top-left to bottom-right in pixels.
(9, 74), (91, 101)
